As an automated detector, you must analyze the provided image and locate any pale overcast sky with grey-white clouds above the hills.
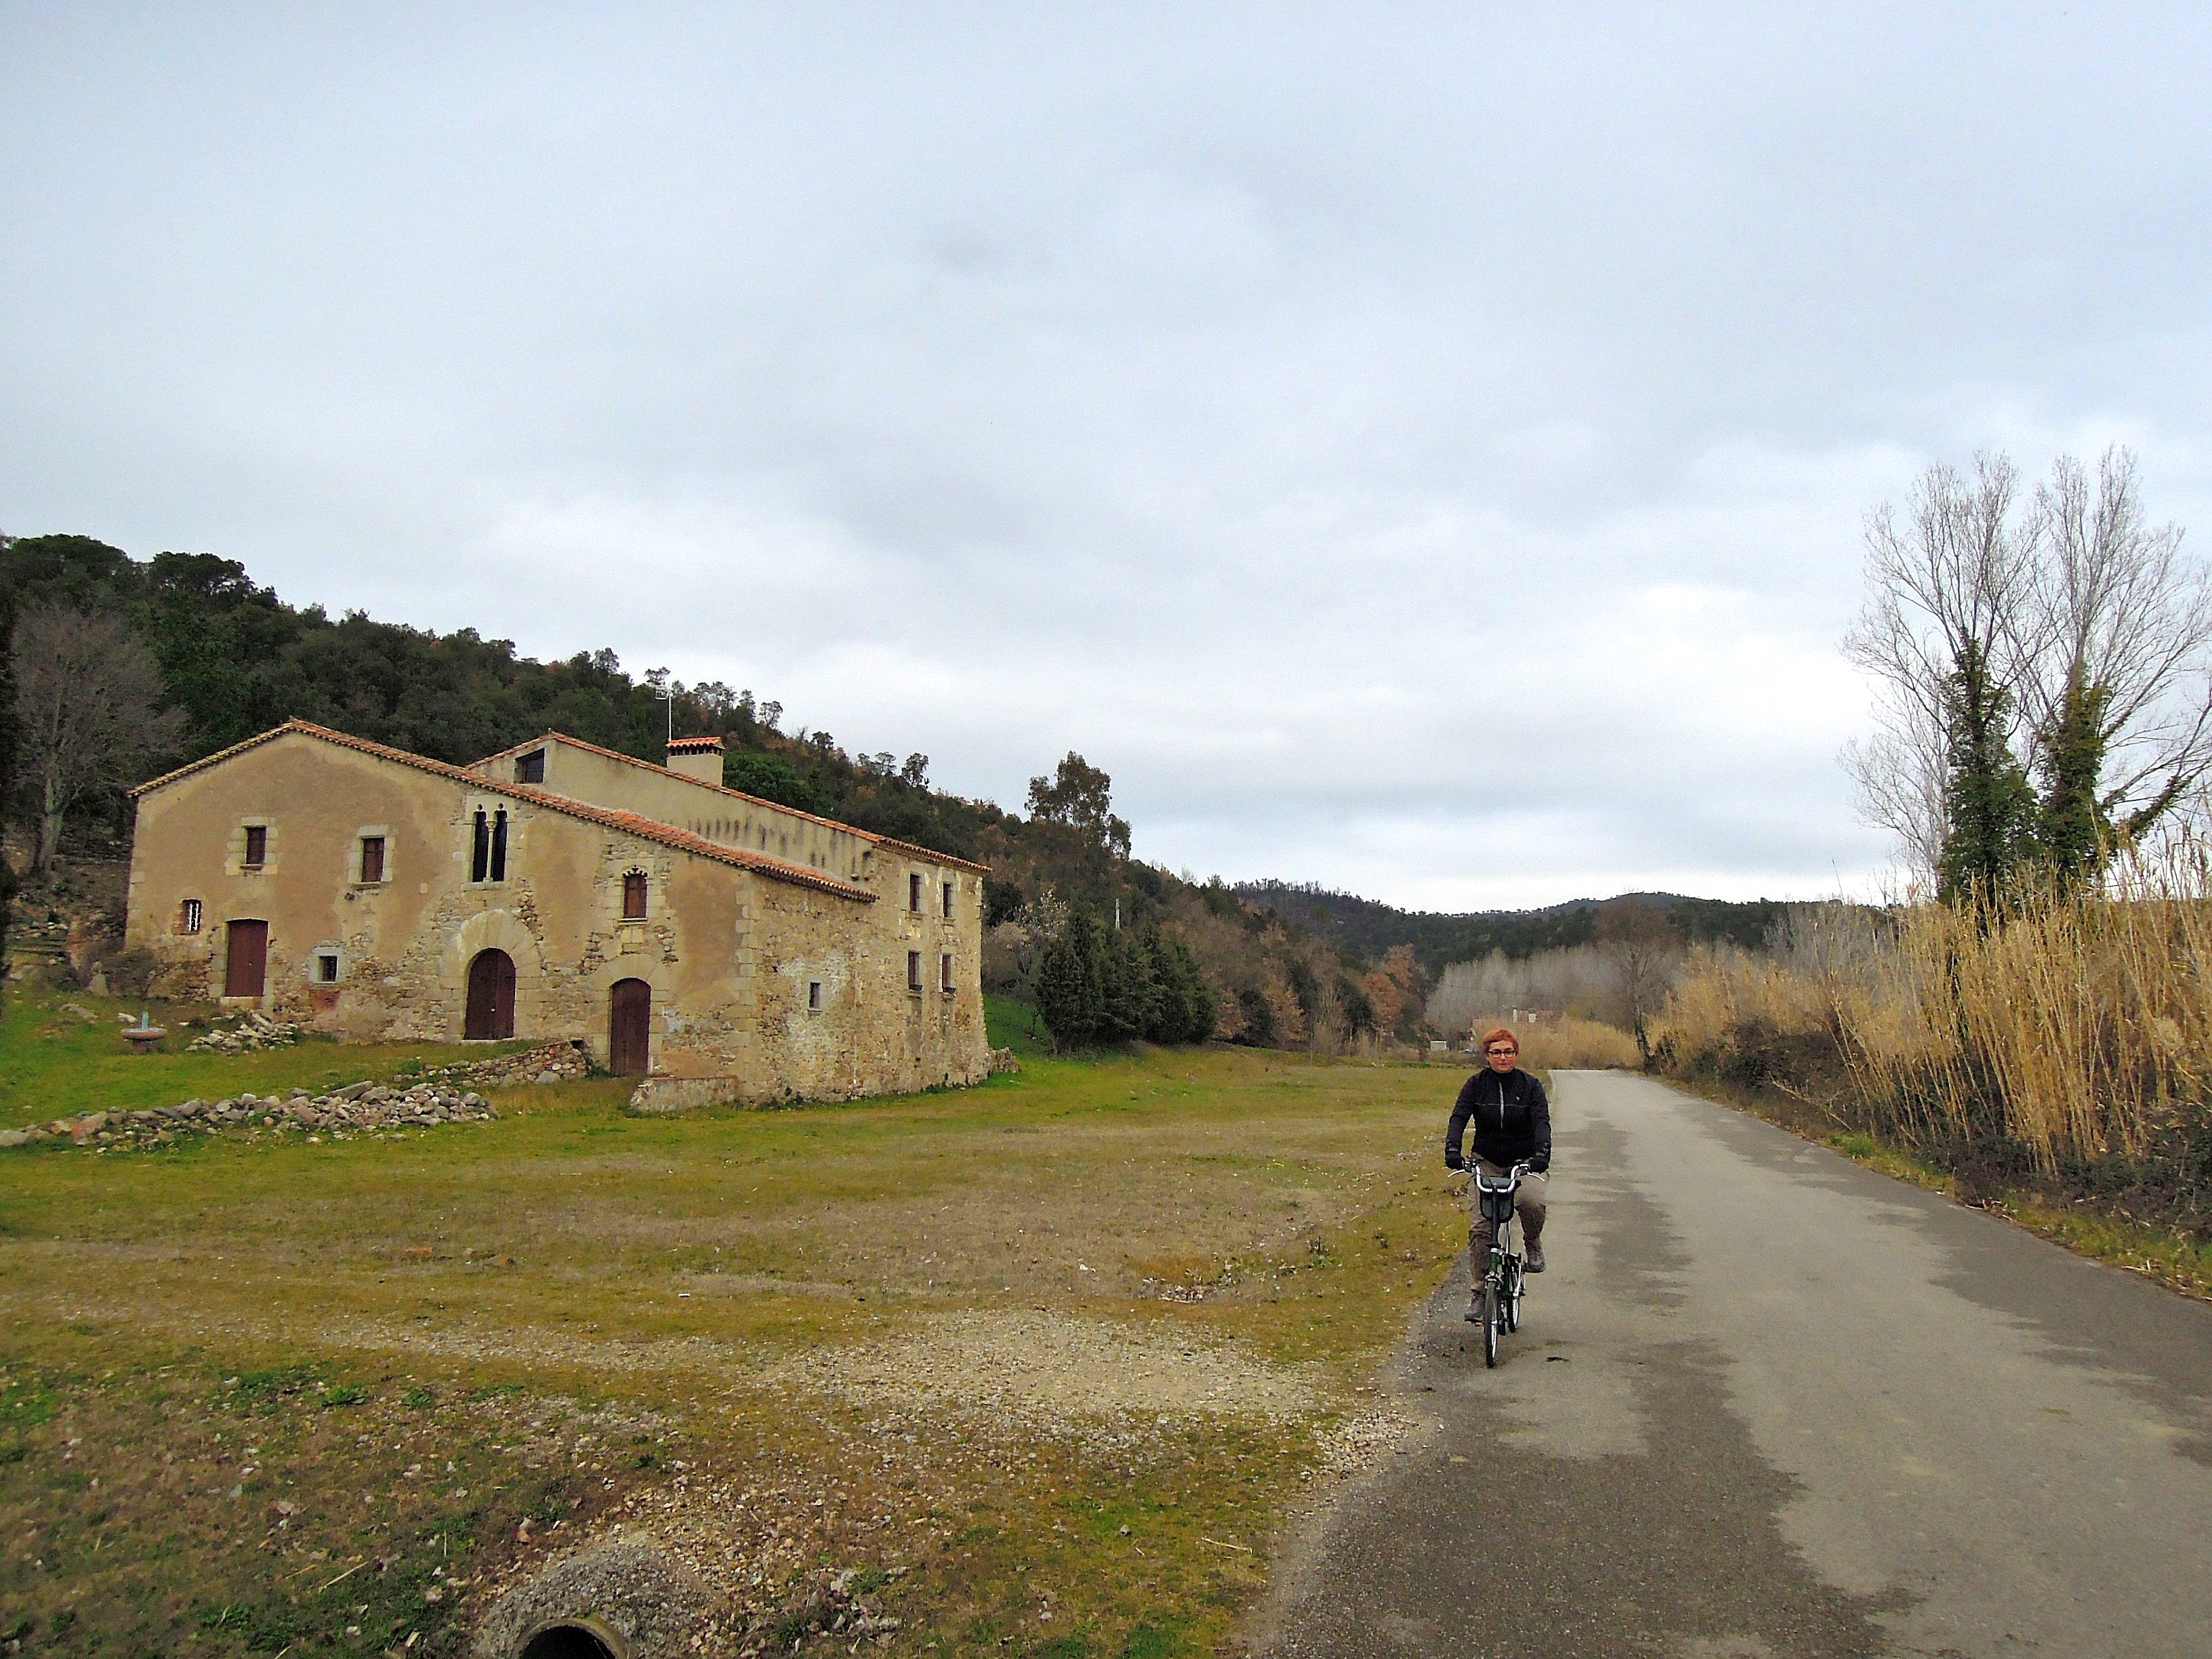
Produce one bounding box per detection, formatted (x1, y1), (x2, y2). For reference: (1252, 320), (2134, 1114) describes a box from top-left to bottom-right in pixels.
(0, 0), (2212, 909)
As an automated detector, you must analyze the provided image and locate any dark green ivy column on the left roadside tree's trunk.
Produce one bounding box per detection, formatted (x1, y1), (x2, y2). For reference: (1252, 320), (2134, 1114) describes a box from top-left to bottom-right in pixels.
(1936, 644), (2035, 905)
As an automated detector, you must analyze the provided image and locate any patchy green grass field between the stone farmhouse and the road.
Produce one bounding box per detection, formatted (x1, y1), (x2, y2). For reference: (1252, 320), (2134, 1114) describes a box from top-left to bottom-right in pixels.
(0, 998), (1465, 1659)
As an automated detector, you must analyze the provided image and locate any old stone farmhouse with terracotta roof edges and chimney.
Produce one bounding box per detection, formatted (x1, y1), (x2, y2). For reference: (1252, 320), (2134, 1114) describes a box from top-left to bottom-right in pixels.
(126, 721), (991, 1106)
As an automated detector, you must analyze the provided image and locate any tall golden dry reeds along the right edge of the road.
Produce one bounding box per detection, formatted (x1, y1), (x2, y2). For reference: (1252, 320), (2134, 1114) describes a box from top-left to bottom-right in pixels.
(1659, 858), (2212, 1232)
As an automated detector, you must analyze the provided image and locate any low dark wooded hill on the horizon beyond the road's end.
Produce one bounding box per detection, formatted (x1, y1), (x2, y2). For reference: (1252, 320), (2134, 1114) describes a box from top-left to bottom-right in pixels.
(1232, 880), (1790, 973)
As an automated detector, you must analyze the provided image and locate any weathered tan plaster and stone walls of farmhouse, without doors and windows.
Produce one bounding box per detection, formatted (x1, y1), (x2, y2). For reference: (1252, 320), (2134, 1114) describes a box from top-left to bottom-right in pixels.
(128, 732), (989, 1099)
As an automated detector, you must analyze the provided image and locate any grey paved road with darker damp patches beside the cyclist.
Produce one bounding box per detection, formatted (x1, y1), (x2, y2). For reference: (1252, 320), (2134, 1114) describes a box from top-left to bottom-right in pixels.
(1258, 1073), (2212, 1659)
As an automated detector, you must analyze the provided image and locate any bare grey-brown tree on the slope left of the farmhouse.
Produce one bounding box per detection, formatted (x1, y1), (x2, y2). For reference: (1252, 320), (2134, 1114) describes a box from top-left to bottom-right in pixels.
(14, 604), (184, 874)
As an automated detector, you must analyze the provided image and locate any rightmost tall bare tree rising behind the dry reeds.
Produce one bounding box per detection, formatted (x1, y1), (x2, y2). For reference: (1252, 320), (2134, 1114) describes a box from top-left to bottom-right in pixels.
(2015, 447), (2212, 840)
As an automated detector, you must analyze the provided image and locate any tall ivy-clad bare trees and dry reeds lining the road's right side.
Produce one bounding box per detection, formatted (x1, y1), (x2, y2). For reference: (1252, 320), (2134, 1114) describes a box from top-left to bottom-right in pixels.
(1654, 449), (2212, 1294)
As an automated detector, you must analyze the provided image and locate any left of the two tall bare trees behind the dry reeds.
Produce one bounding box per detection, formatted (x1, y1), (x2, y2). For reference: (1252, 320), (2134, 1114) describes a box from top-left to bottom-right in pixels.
(1843, 453), (2033, 878)
